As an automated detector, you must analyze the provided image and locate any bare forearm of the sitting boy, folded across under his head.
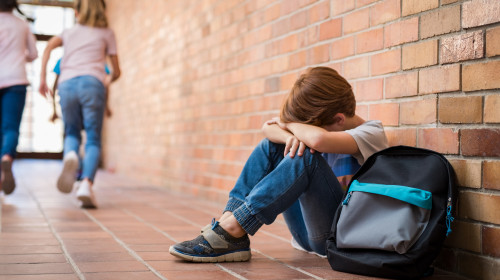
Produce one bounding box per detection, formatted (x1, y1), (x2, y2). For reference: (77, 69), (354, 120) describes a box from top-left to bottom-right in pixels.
(280, 123), (359, 155)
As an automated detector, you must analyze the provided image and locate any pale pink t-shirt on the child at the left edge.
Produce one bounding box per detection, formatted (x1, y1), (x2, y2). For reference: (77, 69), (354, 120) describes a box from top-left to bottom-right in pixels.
(0, 12), (38, 89)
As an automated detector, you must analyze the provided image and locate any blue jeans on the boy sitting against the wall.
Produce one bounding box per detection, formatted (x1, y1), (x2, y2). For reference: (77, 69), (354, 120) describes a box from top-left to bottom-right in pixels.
(224, 139), (343, 255)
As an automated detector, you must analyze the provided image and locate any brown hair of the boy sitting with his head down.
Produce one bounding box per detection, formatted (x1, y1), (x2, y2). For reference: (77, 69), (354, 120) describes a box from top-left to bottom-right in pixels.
(280, 67), (356, 126)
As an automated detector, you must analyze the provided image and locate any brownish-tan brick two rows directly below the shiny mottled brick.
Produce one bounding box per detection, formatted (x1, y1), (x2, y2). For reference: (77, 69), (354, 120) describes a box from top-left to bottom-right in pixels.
(438, 96), (483, 123)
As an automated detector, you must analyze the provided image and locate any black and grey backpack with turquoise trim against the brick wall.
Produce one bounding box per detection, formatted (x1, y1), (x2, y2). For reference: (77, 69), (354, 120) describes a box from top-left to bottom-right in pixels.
(327, 146), (456, 279)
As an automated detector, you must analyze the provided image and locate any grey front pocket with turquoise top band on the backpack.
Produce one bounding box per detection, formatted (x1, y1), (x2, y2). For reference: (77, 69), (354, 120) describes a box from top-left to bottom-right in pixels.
(336, 180), (432, 254)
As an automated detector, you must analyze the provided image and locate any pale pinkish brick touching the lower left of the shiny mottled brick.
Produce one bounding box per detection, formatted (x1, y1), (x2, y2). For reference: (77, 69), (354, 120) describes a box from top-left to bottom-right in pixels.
(418, 65), (460, 94)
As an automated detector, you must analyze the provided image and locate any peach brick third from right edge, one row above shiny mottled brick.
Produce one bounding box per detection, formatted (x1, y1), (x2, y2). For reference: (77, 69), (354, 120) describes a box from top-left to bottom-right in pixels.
(384, 17), (418, 48)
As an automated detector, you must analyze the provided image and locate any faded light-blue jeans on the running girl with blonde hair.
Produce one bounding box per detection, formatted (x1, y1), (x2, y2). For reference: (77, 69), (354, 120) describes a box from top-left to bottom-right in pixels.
(59, 76), (106, 182)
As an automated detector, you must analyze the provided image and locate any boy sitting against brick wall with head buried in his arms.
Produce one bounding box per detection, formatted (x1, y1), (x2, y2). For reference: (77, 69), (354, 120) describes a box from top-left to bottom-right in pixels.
(170, 67), (387, 262)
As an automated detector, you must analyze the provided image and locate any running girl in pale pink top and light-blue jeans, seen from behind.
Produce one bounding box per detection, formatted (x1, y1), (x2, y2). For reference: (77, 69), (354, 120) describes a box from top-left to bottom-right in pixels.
(39, 0), (120, 208)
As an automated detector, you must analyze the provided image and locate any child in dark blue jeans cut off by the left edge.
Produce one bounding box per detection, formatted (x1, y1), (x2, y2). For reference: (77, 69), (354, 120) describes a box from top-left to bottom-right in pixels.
(0, 0), (38, 194)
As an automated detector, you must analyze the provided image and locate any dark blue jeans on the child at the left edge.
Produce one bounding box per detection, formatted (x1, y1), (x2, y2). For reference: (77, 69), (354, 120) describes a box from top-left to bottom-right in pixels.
(0, 85), (26, 158)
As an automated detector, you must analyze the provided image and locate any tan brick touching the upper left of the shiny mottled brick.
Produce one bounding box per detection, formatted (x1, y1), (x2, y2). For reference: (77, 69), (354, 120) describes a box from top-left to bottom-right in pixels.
(420, 6), (460, 39)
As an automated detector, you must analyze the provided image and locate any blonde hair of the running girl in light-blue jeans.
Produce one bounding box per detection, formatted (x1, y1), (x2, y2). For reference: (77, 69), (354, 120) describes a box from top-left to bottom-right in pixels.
(75, 0), (108, 27)
